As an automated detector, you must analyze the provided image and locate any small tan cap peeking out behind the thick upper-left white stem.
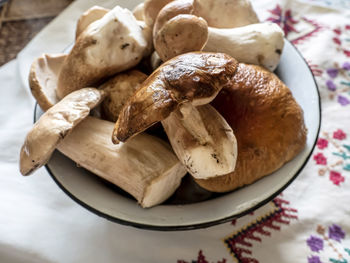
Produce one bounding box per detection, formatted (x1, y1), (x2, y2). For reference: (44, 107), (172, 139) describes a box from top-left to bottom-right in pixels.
(75, 5), (110, 39)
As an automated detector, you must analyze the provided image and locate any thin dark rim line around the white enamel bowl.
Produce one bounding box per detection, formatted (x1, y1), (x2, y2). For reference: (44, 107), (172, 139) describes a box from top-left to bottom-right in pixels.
(34, 39), (322, 231)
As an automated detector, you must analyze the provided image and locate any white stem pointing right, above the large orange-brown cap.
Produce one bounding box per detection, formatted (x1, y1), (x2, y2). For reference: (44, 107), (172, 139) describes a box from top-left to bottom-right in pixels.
(203, 22), (284, 71)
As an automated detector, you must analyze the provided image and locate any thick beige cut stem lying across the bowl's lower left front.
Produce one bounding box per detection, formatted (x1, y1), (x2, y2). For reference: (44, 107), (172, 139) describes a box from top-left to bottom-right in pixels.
(58, 117), (186, 207)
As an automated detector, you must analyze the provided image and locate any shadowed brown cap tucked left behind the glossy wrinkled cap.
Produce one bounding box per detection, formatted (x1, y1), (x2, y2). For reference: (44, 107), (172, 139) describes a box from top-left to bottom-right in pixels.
(99, 70), (147, 122)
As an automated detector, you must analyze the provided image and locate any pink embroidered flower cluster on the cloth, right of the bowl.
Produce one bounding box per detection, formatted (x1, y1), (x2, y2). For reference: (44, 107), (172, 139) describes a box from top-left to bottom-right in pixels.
(313, 129), (350, 186)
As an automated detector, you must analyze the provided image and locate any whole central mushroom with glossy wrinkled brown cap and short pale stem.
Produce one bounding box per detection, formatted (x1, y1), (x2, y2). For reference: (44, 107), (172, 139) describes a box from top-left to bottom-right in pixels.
(112, 52), (237, 178)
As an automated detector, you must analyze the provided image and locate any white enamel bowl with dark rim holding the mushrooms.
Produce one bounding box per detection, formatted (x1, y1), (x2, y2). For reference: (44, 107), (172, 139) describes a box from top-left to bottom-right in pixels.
(34, 40), (321, 231)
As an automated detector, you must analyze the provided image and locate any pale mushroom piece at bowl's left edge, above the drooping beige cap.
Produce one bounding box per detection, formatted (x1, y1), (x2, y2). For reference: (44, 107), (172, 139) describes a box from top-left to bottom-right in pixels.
(29, 54), (67, 111)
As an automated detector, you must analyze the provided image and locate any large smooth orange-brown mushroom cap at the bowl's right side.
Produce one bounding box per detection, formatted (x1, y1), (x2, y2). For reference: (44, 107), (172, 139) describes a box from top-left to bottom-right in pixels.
(196, 63), (307, 192)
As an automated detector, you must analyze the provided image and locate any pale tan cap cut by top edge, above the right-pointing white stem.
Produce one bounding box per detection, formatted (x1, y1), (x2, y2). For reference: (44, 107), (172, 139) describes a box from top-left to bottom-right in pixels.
(194, 0), (259, 28)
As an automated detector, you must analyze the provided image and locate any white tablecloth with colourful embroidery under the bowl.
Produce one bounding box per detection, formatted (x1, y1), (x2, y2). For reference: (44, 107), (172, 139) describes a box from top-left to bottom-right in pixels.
(0, 0), (350, 263)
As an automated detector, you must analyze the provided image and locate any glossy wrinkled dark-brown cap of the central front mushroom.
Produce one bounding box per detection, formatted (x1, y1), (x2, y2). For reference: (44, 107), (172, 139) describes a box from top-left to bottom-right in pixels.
(112, 52), (238, 143)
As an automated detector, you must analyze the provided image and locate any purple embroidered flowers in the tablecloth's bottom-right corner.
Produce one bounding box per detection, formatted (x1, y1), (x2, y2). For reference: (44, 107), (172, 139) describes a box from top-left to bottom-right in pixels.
(306, 224), (350, 263)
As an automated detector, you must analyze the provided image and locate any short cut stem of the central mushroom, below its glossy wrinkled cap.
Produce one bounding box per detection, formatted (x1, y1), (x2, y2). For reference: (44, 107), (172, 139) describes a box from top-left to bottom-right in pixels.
(162, 103), (237, 179)
